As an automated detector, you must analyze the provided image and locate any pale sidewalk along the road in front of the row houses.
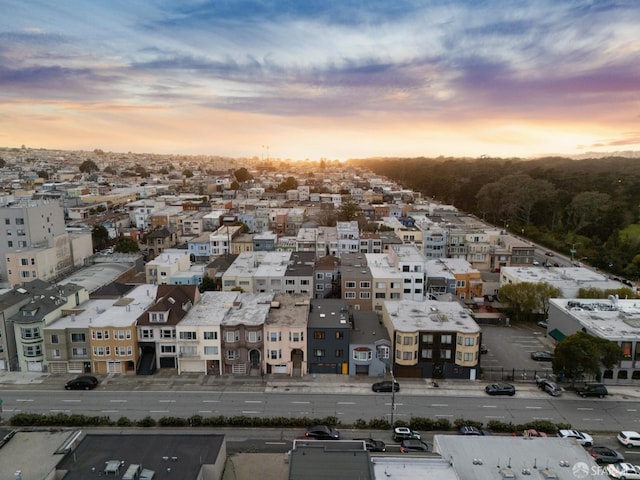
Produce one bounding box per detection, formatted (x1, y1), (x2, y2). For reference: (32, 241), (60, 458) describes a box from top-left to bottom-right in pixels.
(0, 370), (640, 401)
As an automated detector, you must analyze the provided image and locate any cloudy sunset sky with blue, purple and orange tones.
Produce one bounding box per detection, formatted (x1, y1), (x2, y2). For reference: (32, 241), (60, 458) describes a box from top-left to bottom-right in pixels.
(0, 0), (640, 160)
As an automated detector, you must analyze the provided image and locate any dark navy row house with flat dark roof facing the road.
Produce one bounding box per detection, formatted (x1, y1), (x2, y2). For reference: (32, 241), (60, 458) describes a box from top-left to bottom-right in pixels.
(307, 299), (351, 375)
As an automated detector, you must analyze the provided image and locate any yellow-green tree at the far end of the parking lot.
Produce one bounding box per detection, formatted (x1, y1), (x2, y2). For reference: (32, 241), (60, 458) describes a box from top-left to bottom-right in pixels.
(498, 282), (561, 320)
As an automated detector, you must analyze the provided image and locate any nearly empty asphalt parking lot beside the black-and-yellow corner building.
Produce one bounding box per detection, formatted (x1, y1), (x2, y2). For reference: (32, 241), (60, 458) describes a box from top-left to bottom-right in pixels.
(481, 324), (555, 382)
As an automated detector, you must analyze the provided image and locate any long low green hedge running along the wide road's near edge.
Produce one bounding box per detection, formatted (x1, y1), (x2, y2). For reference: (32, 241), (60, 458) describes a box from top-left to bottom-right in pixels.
(9, 413), (571, 434)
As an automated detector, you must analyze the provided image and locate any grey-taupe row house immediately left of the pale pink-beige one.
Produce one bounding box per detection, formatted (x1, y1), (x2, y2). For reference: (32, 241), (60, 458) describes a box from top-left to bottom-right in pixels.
(220, 293), (274, 375)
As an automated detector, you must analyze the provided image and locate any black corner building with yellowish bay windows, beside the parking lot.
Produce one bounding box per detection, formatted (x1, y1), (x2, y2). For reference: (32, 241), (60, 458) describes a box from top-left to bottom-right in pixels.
(382, 300), (482, 380)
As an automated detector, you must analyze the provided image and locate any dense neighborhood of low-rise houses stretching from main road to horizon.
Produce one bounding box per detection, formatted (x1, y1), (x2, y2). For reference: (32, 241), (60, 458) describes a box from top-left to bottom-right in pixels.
(0, 148), (640, 383)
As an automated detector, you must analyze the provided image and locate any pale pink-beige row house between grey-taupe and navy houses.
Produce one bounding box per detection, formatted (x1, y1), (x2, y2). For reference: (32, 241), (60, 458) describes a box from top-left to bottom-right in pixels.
(263, 293), (311, 377)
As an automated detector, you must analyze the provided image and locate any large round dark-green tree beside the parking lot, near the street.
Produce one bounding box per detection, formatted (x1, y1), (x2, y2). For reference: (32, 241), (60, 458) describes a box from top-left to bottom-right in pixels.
(552, 331), (622, 379)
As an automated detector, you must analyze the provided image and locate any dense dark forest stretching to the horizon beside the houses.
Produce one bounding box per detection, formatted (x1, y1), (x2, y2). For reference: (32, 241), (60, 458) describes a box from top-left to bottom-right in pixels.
(349, 157), (640, 280)
